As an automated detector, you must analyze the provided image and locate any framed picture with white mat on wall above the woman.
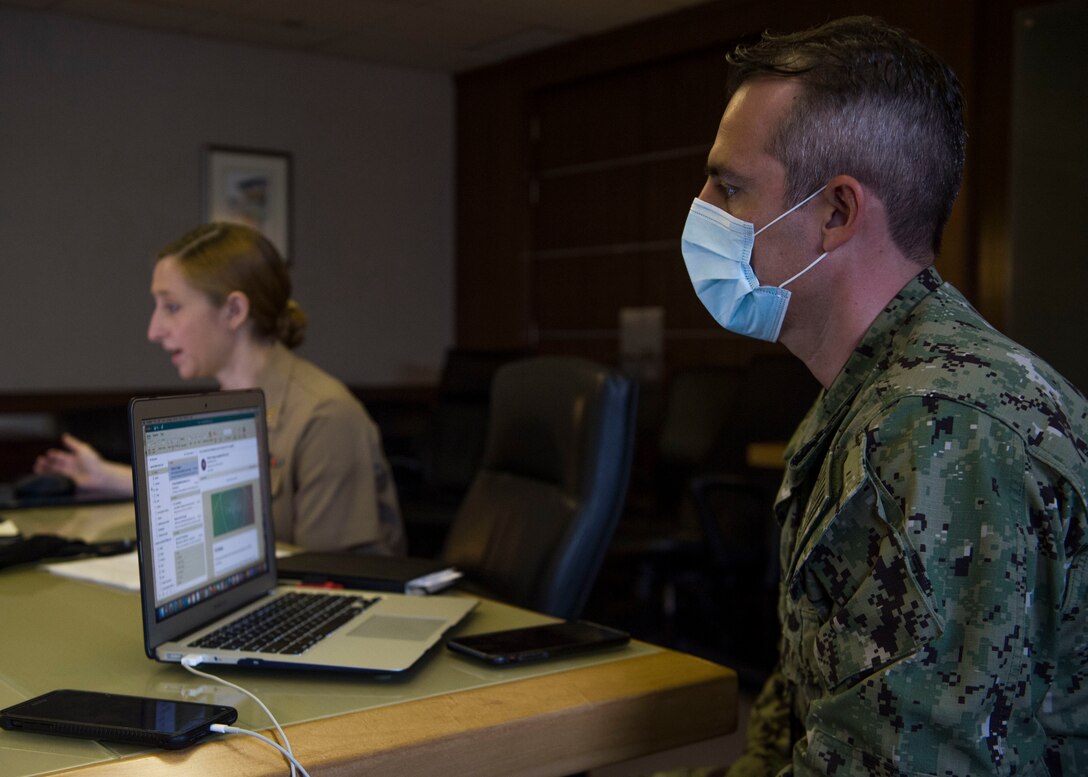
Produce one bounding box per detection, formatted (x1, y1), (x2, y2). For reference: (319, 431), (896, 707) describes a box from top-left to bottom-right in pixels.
(201, 146), (292, 263)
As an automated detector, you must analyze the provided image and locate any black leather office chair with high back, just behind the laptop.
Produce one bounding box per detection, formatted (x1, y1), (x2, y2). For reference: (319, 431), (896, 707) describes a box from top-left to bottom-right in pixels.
(442, 356), (638, 618)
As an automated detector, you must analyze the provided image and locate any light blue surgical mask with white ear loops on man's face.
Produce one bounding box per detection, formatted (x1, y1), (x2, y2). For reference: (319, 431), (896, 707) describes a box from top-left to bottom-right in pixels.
(680, 186), (827, 343)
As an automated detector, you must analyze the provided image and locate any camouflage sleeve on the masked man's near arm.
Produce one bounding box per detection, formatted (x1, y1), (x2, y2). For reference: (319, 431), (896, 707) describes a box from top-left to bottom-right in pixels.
(793, 398), (1065, 777)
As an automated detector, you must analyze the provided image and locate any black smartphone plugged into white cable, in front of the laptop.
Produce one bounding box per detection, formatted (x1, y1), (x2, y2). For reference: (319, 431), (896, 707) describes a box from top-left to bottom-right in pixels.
(0, 689), (238, 750)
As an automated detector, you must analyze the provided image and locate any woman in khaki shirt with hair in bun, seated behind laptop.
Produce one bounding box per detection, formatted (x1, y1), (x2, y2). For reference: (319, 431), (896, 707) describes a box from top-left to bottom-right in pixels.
(35, 223), (405, 555)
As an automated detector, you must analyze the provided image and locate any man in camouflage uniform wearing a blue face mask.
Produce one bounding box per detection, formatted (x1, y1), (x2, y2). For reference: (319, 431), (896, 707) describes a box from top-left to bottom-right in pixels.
(684, 17), (1088, 777)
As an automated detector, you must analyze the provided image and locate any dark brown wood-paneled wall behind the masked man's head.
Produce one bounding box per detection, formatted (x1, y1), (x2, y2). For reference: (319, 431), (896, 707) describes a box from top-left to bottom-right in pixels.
(457, 0), (1024, 368)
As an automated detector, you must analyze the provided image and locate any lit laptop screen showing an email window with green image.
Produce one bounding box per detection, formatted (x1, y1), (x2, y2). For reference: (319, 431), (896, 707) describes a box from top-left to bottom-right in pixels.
(143, 409), (268, 620)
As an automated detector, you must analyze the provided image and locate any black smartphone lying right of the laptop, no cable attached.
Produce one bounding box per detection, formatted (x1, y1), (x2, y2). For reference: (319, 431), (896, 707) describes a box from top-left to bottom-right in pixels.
(446, 620), (631, 665)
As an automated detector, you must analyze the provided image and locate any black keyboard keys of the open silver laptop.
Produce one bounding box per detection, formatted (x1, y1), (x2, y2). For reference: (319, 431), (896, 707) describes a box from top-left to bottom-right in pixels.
(189, 592), (378, 655)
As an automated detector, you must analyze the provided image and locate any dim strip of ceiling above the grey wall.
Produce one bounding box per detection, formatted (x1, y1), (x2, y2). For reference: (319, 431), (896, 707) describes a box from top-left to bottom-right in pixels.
(0, 0), (708, 73)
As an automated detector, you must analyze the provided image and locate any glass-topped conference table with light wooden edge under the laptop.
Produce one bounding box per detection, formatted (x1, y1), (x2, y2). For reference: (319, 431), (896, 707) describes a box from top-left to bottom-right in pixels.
(0, 505), (737, 777)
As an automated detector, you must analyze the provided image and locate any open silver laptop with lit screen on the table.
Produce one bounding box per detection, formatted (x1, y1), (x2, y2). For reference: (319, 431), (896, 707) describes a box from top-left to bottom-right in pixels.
(128, 390), (477, 673)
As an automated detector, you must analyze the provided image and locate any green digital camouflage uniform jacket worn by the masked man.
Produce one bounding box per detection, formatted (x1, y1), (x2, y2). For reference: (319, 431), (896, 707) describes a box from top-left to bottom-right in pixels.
(729, 269), (1088, 777)
